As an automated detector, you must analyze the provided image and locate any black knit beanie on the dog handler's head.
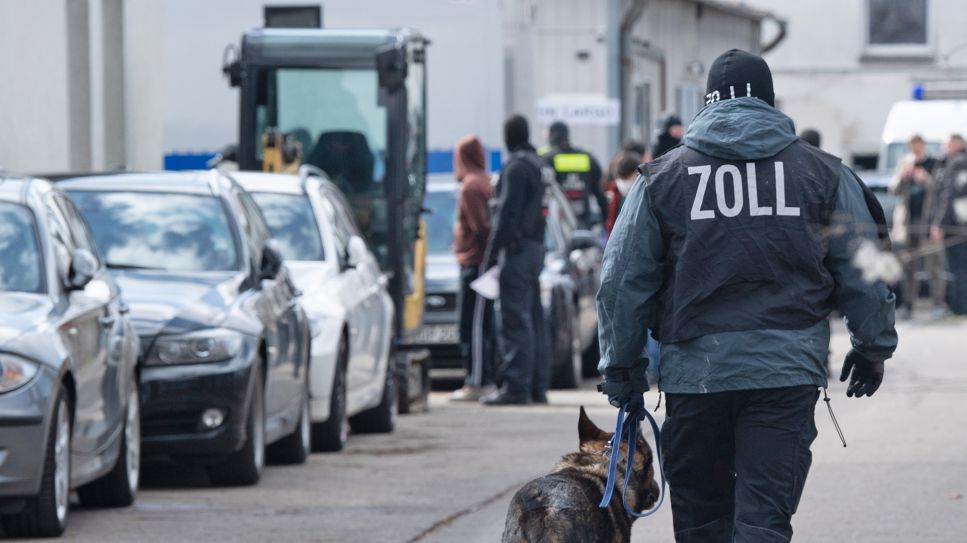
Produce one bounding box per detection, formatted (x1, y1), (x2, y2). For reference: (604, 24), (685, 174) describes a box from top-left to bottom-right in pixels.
(705, 49), (776, 107)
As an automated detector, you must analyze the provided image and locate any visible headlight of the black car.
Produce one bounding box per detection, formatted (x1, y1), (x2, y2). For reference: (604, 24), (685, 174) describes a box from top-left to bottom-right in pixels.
(146, 328), (243, 365)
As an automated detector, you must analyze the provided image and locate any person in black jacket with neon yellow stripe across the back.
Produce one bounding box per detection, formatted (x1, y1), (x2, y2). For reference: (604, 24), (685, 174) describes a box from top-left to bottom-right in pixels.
(541, 122), (608, 228)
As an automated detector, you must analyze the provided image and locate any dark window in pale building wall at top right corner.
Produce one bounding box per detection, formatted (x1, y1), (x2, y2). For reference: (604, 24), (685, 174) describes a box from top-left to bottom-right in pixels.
(867, 0), (929, 49)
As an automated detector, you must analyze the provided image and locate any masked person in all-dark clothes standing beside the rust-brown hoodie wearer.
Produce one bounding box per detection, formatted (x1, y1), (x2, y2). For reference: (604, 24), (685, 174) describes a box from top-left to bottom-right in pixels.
(481, 115), (550, 405)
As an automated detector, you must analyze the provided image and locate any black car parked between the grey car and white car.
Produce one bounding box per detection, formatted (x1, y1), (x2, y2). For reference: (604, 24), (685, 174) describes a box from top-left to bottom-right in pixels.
(60, 171), (310, 485)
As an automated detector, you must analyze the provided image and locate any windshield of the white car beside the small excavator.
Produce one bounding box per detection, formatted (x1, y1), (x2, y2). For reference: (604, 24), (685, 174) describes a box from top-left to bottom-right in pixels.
(252, 192), (325, 260)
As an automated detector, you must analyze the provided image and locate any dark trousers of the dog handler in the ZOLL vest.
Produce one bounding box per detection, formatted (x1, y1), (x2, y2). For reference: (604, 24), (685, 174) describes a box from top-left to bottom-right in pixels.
(661, 386), (819, 543)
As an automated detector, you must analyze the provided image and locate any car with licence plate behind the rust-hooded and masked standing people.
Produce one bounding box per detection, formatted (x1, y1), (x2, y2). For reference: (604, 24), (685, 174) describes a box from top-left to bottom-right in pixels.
(414, 178), (602, 388)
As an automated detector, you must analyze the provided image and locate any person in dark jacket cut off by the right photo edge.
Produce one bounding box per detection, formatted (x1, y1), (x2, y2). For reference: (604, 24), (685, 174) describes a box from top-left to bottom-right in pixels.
(930, 134), (967, 315)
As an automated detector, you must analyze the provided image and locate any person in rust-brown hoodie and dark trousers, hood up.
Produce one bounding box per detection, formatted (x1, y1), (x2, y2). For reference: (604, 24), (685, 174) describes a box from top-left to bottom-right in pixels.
(450, 136), (496, 402)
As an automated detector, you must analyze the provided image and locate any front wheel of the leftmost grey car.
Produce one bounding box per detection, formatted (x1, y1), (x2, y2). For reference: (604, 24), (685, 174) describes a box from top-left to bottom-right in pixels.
(2, 389), (71, 537)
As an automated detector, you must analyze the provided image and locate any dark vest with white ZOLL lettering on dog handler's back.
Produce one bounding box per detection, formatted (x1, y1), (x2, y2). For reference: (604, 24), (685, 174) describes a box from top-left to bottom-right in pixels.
(643, 141), (841, 342)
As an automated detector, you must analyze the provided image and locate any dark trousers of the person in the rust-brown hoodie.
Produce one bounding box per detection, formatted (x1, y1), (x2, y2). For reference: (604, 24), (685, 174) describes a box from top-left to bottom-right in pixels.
(460, 266), (496, 386)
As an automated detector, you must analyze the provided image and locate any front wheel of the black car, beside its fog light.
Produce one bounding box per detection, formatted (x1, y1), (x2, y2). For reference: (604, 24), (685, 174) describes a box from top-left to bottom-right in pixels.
(208, 361), (265, 486)
